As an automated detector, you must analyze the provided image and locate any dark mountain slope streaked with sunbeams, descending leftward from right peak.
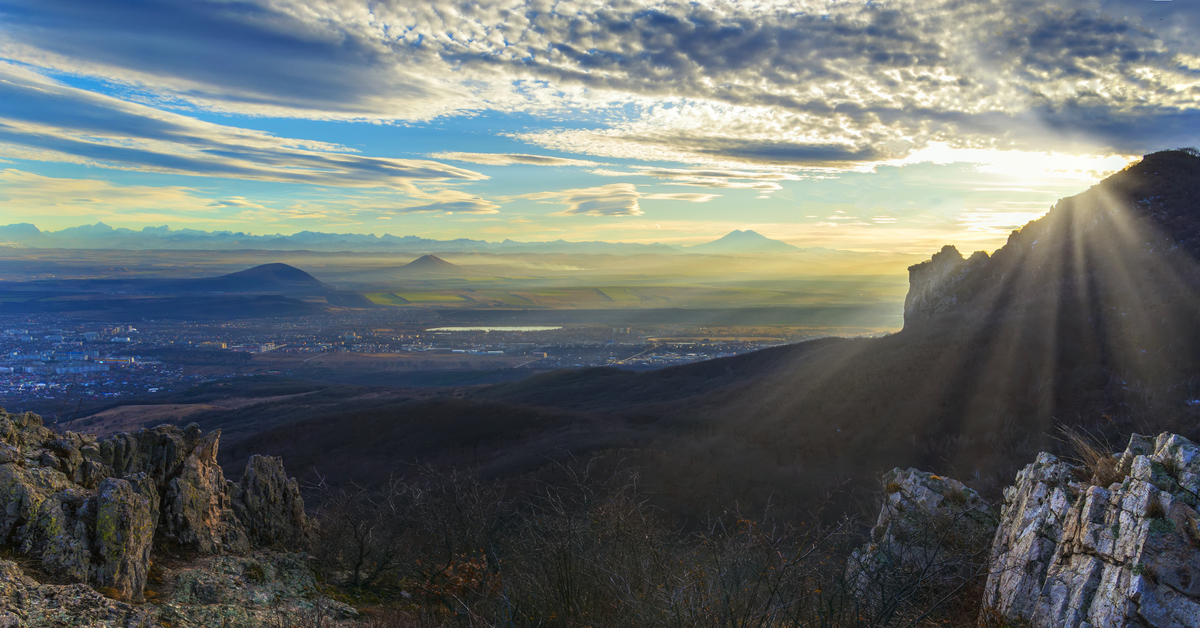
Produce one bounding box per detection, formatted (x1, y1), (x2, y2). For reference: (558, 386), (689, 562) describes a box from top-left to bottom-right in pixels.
(199, 151), (1200, 519)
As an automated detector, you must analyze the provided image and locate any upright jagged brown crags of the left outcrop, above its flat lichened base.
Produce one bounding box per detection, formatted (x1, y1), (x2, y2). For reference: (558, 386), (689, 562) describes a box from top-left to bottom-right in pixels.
(0, 411), (306, 602)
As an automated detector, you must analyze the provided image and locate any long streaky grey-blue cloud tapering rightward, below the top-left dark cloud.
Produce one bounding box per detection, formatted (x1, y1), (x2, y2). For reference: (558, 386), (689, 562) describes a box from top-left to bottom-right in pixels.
(0, 62), (486, 190)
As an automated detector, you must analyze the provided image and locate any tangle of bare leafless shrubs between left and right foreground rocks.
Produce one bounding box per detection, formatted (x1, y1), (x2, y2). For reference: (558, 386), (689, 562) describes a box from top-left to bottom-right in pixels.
(309, 463), (985, 628)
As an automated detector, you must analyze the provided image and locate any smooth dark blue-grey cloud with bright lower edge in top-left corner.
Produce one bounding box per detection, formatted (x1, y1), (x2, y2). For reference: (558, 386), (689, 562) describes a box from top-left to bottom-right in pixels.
(0, 0), (475, 119)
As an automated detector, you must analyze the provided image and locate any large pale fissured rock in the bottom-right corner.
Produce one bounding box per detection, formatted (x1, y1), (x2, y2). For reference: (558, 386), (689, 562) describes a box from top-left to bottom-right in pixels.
(984, 433), (1200, 627)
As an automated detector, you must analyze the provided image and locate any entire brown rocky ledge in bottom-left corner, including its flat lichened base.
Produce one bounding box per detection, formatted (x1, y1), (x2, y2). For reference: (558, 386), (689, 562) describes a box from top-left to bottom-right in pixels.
(0, 411), (353, 628)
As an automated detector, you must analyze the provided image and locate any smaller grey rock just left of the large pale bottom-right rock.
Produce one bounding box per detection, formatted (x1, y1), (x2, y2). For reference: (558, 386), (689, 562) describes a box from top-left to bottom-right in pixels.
(846, 468), (997, 604)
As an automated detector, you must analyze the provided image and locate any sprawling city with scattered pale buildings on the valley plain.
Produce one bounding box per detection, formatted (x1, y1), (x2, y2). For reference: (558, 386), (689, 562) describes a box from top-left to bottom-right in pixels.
(0, 311), (854, 417)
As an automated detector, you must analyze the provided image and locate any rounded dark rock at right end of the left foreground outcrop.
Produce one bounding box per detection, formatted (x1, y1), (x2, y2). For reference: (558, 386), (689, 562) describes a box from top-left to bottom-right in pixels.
(232, 455), (306, 545)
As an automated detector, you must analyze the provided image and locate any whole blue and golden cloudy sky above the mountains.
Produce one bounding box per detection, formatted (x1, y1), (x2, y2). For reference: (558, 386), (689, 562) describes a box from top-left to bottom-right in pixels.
(0, 0), (1200, 252)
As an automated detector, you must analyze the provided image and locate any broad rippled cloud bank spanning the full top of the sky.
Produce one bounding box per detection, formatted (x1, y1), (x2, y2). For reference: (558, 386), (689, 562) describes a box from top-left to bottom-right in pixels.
(0, 0), (1200, 171)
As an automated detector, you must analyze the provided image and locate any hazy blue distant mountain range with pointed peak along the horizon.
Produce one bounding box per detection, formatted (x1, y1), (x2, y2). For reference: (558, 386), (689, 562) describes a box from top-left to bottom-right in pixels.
(0, 222), (799, 255)
